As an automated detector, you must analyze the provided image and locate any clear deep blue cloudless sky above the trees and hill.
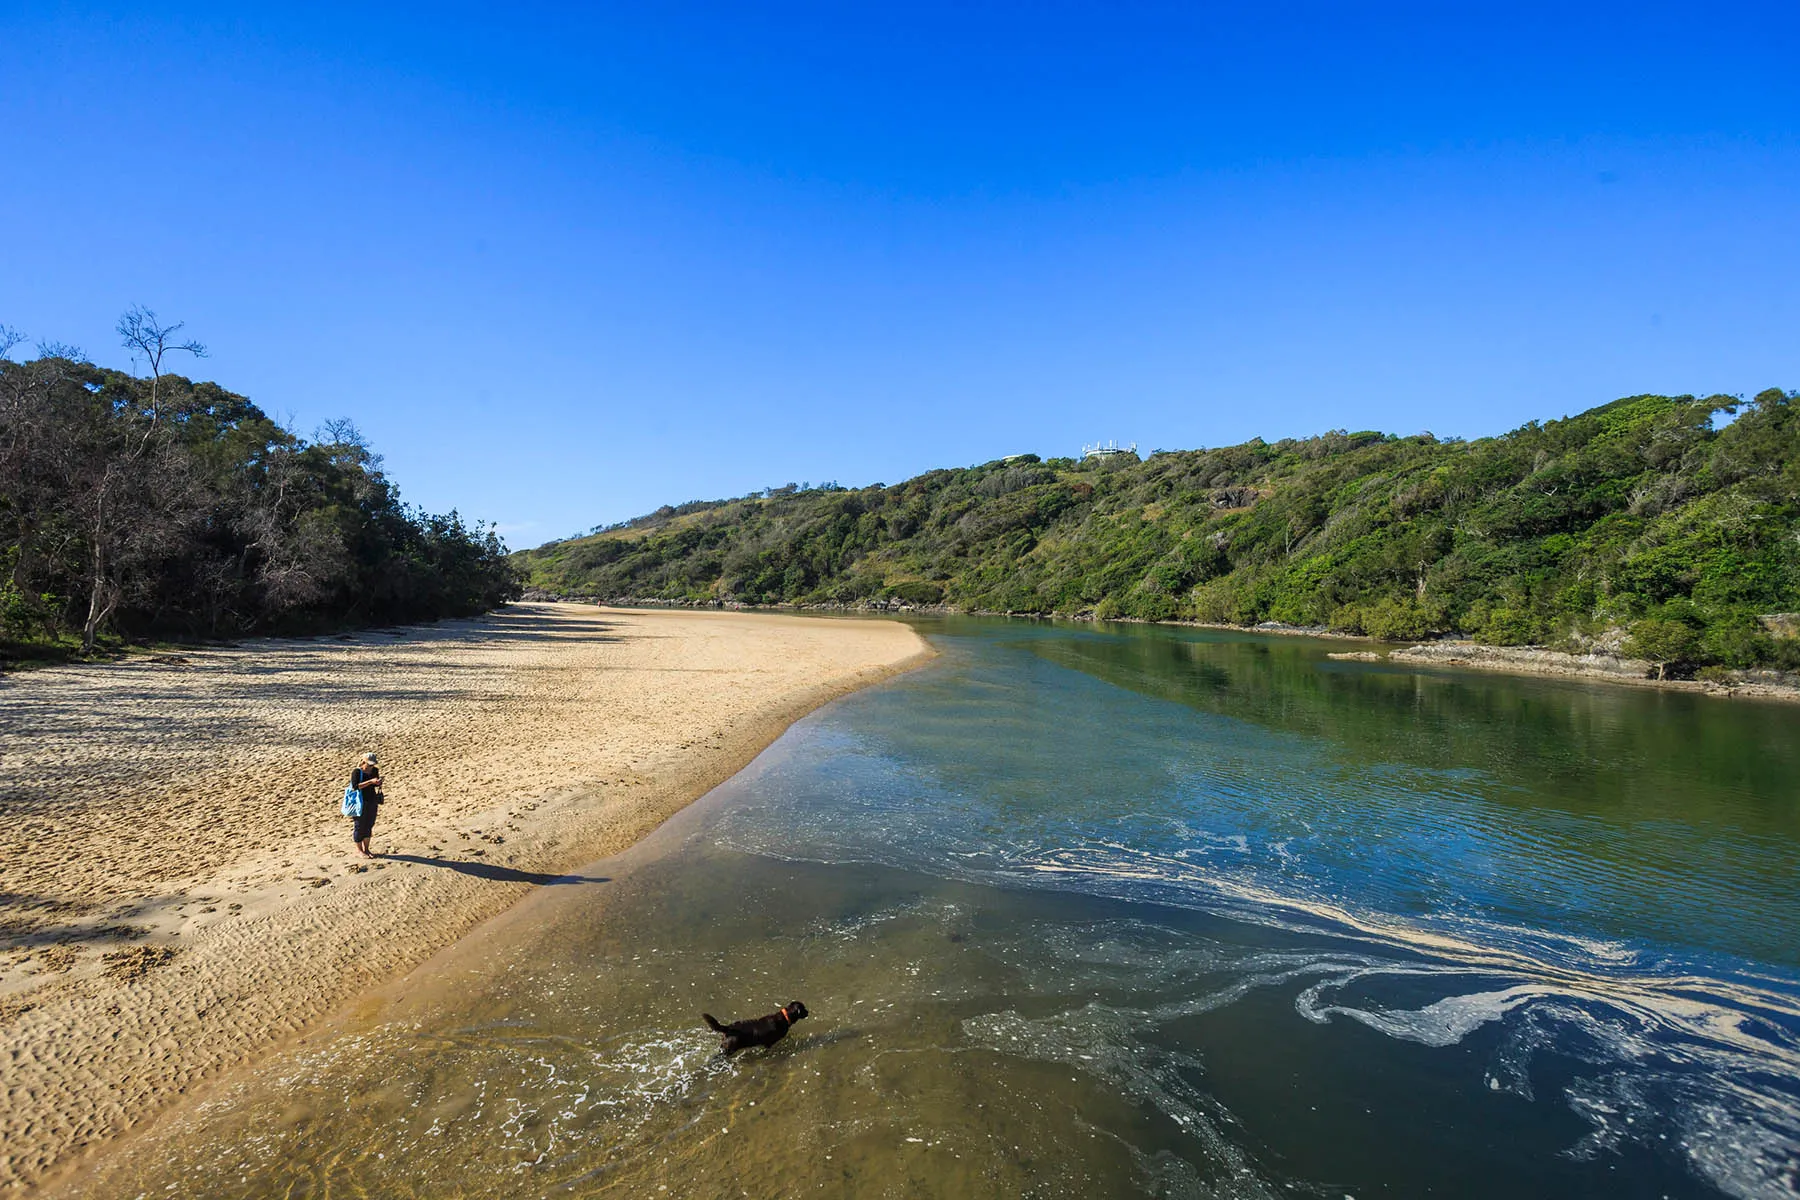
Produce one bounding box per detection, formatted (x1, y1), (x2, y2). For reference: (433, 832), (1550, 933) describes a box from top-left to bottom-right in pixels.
(0, 0), (1800, 547)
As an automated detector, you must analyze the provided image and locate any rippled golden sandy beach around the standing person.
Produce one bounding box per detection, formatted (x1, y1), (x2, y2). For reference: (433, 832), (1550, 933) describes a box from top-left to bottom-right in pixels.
(0, 604), (929, 1191)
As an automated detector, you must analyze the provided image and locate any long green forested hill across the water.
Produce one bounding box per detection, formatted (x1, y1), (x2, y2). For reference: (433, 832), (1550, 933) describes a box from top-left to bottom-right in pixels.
(515, 390), (1800, 666)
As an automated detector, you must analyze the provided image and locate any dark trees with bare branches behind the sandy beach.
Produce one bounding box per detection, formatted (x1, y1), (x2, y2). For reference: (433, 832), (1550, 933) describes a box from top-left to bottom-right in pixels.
(0, 309), (518, 653)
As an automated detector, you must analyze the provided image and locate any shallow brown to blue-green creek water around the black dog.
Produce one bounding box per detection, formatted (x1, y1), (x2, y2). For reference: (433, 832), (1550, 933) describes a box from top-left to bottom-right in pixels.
(73, 621), (1800, 1200)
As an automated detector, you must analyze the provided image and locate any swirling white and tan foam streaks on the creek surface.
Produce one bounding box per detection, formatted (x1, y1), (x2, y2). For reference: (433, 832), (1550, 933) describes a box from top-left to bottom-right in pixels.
(722, 810), (1800, 1200)
